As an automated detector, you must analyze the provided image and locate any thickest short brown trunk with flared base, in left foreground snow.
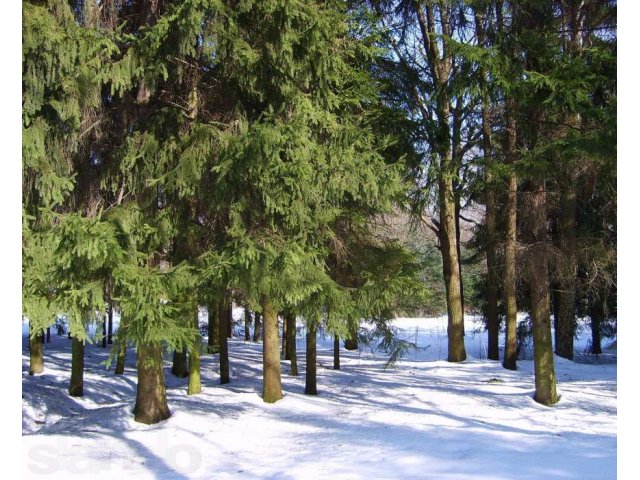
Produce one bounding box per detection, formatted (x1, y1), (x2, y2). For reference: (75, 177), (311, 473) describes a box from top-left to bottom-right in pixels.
(133, 344), (171, 424)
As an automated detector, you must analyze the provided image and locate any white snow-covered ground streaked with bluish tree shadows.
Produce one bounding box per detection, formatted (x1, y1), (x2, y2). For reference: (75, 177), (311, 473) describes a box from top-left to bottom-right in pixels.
(22, 312), (617, 480)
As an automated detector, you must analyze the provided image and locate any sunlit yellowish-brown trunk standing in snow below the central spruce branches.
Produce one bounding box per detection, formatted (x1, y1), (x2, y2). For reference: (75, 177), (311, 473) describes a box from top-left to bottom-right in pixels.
(262, 297), (282, 403)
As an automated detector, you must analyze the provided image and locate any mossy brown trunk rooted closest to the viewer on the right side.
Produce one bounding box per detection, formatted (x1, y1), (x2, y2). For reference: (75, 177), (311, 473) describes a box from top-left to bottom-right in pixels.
(528, 181), (558, 405)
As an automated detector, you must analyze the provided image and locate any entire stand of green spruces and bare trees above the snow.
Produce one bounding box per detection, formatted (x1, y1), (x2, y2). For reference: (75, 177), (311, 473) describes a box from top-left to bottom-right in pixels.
(21, 0), (617, 476)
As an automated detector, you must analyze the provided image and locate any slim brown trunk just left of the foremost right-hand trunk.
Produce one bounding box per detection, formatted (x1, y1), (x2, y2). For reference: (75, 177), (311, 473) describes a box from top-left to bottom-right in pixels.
(502, 98), (518, 370)
